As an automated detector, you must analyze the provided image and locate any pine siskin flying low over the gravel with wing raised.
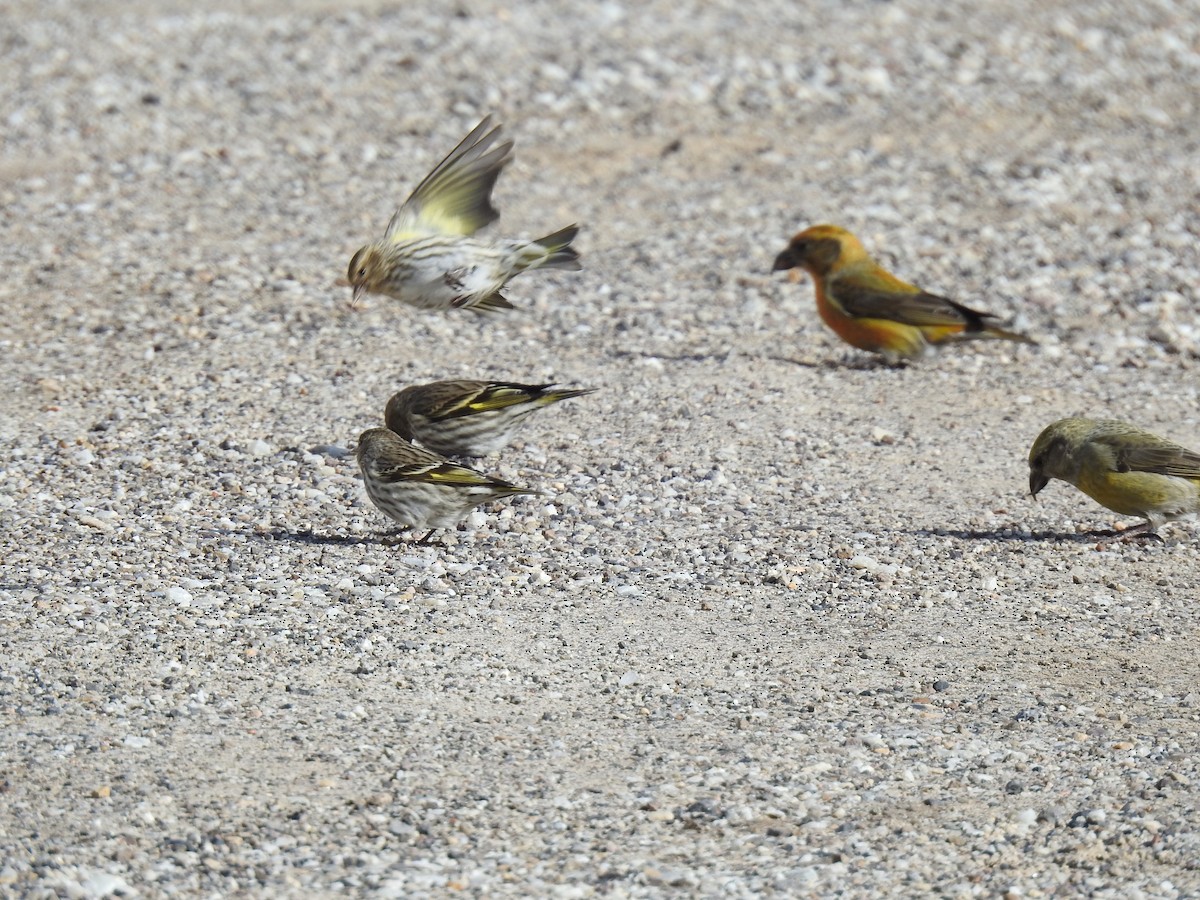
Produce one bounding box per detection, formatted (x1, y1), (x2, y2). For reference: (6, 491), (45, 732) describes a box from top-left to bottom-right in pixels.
(348, 116), (580, 311)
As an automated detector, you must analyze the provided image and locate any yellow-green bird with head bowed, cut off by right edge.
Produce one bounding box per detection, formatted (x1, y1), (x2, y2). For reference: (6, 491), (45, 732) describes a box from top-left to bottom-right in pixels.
(1030, 419), (1200, 539)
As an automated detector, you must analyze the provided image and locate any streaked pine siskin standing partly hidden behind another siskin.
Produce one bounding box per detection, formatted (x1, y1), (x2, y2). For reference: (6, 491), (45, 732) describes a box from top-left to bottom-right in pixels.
(384, 382), (592, 456)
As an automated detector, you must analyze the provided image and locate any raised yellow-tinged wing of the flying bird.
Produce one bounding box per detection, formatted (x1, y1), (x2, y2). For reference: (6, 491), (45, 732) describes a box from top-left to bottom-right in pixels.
(384, 116), (512, 241)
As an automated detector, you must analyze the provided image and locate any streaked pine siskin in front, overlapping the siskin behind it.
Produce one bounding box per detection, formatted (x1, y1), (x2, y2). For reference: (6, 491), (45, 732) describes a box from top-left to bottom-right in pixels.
(355, 428), (536, 544)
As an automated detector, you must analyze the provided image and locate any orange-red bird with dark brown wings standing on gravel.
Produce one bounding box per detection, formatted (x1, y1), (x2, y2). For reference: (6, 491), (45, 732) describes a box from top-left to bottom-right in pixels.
(773, 224), (1037, 362)
